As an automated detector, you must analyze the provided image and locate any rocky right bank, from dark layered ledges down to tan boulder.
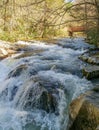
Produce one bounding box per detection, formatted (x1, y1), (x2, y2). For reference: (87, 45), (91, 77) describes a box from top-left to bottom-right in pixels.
(70, 44), (99, 130)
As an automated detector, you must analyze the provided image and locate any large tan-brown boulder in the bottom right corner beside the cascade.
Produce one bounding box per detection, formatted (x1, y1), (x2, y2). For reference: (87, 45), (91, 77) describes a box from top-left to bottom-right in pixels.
(69, 86), (99, 130)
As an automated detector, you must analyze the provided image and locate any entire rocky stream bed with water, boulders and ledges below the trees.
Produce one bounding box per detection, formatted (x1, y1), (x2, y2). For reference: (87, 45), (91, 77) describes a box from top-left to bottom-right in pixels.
(0, 38), (99, 130)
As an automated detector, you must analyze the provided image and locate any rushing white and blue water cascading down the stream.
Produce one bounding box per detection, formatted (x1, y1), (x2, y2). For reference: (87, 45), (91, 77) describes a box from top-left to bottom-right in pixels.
(0, 39), (92, 130)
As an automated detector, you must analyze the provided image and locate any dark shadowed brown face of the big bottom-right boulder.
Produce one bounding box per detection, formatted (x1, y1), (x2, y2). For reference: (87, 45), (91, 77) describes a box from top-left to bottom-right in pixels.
(70, 101), (99, 130)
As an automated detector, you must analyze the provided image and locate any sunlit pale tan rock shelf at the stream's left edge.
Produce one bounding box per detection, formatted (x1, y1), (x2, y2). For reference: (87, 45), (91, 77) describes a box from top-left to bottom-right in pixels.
(0, 41), (43, 60)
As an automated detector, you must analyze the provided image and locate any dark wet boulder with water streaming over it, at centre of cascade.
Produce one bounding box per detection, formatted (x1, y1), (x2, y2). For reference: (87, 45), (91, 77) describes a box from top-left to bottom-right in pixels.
(17, 76), (59, 114)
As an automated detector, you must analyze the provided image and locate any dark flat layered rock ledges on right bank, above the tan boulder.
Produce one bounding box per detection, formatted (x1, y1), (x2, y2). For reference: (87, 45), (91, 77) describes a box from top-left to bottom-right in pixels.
(80, 48), (99, 79)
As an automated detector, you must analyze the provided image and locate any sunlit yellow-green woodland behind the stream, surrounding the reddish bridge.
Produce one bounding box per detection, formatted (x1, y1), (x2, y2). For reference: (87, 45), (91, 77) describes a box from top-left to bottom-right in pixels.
(0, 0), (99, 45)
